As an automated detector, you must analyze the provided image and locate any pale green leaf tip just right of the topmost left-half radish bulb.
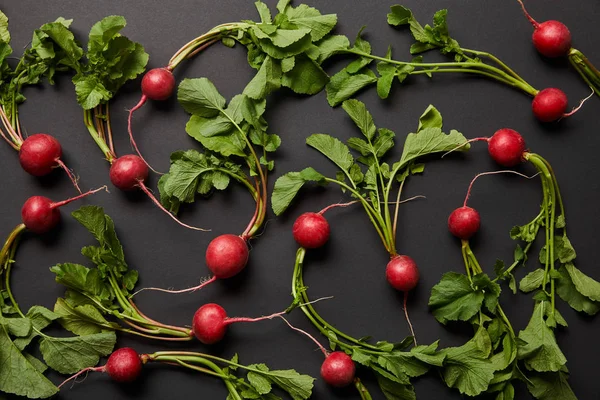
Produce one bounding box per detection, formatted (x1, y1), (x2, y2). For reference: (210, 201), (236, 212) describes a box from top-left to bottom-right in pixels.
(177, 78), (225, 118)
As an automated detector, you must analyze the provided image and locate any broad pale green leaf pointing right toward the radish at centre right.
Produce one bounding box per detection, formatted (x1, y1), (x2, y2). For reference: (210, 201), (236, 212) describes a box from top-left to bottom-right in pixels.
(400, 128), (471, 166)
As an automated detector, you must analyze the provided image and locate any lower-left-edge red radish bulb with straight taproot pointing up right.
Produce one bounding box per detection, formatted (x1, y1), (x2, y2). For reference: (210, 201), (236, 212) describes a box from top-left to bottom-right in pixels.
(21, 186), (106, 234)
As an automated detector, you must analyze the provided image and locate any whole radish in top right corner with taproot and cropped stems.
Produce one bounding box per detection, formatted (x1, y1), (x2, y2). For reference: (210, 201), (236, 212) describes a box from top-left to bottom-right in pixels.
(517, 0), (600, 99)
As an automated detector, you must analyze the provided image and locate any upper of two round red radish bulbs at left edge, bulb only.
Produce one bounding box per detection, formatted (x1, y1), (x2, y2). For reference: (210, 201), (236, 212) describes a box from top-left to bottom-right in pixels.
(19, 133), (62, 176)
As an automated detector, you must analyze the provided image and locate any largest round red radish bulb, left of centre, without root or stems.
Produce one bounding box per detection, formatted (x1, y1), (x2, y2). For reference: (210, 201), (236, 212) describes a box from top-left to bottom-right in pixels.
(206, 234), (250, 279)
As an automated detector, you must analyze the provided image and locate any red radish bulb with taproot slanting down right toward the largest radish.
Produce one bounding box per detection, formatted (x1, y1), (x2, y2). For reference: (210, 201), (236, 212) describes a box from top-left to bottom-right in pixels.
(110, 154), (206, 231)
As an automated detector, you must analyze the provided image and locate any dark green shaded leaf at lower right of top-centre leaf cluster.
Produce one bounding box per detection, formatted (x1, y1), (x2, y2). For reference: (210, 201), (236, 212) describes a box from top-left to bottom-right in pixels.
(281, 54), (329, 95)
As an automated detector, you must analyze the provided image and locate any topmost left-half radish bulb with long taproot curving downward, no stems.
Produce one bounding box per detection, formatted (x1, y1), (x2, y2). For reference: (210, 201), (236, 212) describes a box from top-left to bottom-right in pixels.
(127, 68), (175, 168)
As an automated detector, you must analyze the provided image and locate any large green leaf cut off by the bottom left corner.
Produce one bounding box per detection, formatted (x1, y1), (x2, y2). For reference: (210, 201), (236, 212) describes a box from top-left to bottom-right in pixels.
(0, 326), (58, 399)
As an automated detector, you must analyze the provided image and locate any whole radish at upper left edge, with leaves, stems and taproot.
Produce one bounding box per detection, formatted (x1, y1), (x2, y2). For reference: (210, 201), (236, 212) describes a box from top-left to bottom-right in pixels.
(0, 11), (81, 193)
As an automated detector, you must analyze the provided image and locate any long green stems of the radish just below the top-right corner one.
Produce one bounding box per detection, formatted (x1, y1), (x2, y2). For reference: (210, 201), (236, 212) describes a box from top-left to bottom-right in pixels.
(342, 49), (538, 96)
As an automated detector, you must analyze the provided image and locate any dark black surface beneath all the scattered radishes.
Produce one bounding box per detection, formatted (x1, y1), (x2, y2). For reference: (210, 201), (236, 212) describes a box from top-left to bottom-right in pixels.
(0, 0), (600, 400)
